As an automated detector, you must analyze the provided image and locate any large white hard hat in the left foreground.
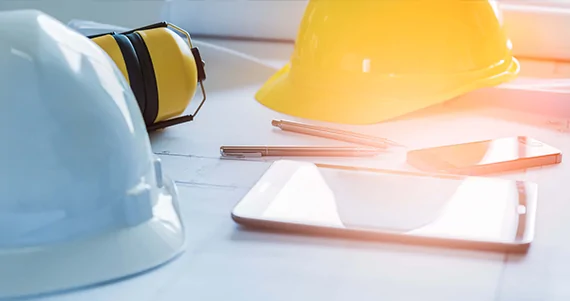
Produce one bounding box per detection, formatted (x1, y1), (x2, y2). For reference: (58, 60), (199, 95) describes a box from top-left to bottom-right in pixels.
(0, 10), (185, 299)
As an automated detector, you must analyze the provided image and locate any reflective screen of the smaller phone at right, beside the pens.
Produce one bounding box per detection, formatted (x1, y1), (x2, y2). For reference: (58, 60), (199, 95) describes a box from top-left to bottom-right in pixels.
(429, 136), (558, 168)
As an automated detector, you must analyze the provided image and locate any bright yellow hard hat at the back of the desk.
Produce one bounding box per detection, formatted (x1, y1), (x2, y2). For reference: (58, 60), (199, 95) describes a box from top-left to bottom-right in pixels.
(255, 0), (520, 124)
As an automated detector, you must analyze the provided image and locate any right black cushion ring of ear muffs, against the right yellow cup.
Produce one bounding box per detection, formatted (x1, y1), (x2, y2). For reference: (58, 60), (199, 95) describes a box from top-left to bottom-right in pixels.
(125, 32), (158, 126)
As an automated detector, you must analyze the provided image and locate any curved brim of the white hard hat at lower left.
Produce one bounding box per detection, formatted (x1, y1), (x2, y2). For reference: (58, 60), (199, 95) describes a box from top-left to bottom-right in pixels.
(0, 180), (185, 299)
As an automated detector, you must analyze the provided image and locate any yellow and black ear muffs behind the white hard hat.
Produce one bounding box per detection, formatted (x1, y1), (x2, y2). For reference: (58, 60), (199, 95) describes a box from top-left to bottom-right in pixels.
(89, 22), (206, 131)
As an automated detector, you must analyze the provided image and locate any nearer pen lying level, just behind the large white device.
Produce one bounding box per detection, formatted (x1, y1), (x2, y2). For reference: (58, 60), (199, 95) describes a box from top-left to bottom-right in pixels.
(220, 146), (384, 157)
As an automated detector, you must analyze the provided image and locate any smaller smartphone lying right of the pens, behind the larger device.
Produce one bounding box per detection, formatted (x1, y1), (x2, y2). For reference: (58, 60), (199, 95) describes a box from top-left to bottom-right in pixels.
(408, 136), (560, 170)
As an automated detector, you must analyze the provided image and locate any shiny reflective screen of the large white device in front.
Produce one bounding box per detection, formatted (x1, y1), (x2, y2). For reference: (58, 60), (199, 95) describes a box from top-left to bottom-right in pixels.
(263, 165), (519, 241)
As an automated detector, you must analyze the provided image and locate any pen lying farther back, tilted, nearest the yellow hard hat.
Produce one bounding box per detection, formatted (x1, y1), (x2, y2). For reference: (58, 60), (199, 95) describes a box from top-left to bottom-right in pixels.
(271, 120), (403, 148)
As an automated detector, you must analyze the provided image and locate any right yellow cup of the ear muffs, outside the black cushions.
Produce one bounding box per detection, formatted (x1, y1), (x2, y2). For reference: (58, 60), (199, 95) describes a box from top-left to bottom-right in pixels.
(137, 27), (197, 122)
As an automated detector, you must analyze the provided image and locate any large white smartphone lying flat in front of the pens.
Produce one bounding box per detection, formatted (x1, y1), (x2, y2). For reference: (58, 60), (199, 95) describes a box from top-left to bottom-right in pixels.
(232, 160), (537, 252)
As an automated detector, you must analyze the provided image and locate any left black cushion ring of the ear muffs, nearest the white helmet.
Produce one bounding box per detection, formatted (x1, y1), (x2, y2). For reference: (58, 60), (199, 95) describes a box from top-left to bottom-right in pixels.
(113, 34), (147, 114)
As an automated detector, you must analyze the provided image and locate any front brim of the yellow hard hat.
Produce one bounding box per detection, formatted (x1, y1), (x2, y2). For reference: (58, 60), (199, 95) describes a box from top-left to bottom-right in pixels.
(255, 57), (520, 124)
